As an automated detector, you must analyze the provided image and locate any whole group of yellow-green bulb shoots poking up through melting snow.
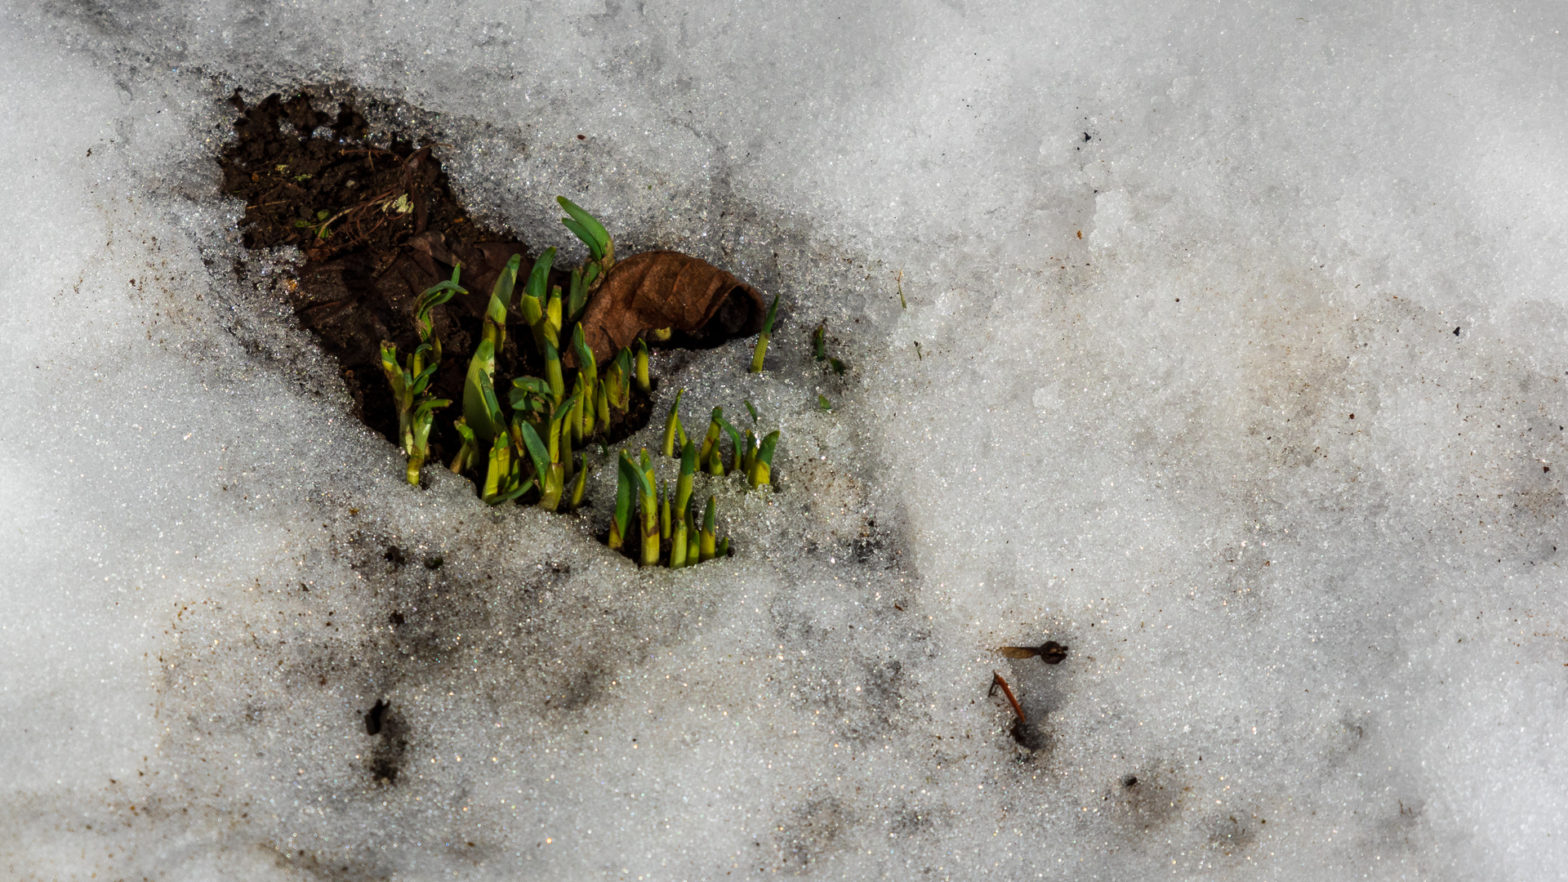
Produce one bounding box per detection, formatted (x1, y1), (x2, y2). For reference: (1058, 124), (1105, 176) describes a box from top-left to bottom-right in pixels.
(381, 196), (779, 568)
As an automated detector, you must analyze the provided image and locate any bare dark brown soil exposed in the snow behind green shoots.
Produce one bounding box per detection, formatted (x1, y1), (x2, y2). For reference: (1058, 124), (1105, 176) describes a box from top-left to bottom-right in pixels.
(221, 94), (651, 463)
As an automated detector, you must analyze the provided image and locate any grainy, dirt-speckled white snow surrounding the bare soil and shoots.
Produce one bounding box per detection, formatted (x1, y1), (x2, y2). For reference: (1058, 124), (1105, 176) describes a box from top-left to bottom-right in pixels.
(0, 0), (1568, 880)
